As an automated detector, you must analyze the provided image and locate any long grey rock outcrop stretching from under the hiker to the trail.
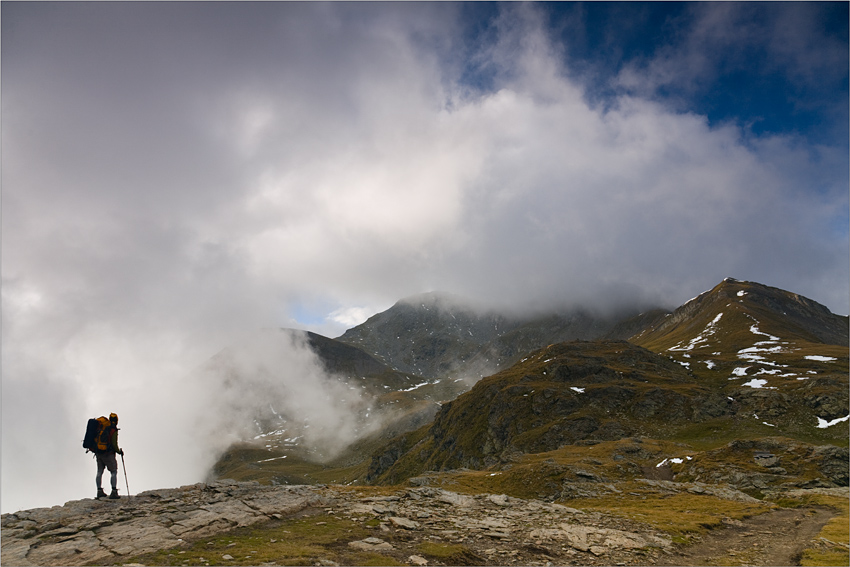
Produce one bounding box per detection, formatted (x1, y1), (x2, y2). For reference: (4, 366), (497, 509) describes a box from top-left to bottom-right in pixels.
(2, 481), (671, 565)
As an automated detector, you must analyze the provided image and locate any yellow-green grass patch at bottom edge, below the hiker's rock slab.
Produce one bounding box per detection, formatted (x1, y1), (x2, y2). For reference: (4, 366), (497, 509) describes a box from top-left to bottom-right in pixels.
(119, 514), (402, 565)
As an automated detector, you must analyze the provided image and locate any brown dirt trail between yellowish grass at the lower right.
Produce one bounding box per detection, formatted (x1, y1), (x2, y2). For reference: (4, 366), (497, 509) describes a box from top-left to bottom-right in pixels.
(656, 508), (835, 565)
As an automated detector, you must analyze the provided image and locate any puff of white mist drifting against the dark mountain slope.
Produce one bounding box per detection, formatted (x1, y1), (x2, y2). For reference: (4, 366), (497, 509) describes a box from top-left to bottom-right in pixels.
(194, 329), (381, 462)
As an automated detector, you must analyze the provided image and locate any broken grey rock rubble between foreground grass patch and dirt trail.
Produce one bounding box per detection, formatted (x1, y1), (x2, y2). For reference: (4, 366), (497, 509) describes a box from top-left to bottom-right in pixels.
(335, 486), (672, 565)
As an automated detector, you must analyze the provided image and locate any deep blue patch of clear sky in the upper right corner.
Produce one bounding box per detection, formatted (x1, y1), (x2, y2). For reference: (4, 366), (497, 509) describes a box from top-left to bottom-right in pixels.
(547, 2), (848, 144)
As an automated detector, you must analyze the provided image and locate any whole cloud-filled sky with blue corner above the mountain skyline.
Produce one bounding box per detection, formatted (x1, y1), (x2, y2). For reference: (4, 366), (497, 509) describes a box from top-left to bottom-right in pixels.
(0, 2), (850, 511)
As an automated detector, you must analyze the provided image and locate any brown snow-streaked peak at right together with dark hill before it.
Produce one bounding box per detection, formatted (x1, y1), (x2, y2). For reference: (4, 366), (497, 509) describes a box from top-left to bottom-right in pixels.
(367, 278), (850, 483)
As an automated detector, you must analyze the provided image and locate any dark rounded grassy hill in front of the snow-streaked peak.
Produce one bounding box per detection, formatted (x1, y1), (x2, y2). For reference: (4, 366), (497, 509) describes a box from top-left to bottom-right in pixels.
(368, 341), (734, 482)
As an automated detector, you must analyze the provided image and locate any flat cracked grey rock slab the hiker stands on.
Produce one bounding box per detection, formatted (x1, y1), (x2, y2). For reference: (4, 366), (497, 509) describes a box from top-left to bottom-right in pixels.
(0, 481), (329, 565)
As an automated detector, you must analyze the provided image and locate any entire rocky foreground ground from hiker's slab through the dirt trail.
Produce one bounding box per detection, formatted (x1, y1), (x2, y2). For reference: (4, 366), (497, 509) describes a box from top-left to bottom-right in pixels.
(2, 481), (846, 565)
